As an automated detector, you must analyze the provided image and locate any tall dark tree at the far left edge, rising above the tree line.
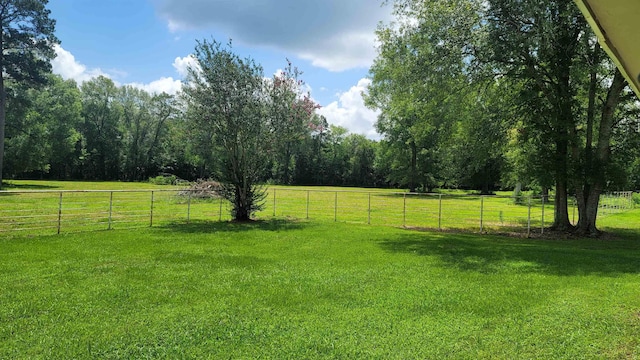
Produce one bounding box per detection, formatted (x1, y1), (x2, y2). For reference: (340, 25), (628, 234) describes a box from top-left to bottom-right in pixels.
(0, 0), (58, 188)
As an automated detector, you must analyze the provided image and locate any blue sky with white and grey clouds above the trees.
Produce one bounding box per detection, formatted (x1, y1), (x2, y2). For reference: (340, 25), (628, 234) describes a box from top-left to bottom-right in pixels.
(48, 0), (391, 138)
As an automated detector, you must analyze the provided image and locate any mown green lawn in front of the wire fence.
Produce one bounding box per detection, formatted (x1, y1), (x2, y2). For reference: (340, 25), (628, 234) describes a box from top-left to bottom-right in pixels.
(0, 210), (640, 359)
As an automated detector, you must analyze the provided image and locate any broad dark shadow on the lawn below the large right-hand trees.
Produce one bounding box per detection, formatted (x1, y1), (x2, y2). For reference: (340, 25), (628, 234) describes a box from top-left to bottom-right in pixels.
(380, 232), (640, 276)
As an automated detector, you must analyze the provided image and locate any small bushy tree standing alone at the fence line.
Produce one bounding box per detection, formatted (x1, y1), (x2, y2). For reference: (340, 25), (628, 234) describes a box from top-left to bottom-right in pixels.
(183, 40), (271, 221)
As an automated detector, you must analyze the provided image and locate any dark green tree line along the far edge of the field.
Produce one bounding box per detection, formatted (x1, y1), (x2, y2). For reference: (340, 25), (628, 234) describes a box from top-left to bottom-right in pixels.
(4, 72), (396, 187)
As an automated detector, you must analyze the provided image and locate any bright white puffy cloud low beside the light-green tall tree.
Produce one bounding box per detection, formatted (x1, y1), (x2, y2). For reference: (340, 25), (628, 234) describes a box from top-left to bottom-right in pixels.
(318, 79), (381, 140)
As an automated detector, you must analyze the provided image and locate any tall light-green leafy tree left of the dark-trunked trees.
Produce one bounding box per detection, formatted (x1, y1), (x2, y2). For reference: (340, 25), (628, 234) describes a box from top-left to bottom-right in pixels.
(365, 0), (480, 191)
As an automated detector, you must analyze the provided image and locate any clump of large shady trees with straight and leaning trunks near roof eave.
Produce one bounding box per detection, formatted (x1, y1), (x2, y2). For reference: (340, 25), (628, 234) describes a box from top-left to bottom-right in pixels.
(487, 0), (626, 234)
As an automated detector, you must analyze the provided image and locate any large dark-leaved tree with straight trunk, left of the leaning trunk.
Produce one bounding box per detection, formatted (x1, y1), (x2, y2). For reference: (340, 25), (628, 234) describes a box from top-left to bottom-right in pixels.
(488, 0), (586, 230)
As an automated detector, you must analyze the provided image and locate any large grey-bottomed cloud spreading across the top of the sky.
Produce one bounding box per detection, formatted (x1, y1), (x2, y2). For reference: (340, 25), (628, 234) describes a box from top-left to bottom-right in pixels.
(153, 0), (392, 71)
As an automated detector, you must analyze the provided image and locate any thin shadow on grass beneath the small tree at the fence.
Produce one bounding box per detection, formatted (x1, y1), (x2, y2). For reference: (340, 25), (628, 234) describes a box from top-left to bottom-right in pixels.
(159, 219), (311, 234)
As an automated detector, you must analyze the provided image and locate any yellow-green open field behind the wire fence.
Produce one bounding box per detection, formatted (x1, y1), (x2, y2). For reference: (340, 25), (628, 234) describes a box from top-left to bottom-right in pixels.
(0, 187), (633, 235)
